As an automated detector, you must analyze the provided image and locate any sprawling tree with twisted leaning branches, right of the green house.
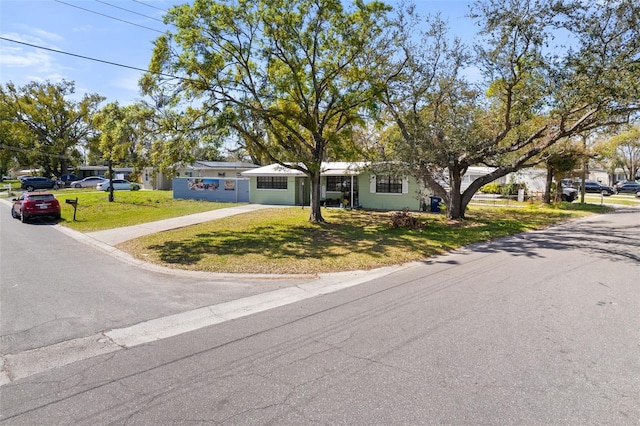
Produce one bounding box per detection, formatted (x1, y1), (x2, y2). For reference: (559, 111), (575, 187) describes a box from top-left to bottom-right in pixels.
(387, 0), (640, 218)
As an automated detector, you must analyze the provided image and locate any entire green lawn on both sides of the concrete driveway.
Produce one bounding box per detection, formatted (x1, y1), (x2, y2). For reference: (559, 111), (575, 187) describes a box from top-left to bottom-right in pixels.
(1, 189), (638, 274)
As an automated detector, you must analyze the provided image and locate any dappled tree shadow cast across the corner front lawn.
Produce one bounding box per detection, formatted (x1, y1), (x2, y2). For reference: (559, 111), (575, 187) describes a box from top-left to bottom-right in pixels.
(146, 212), (532, 266)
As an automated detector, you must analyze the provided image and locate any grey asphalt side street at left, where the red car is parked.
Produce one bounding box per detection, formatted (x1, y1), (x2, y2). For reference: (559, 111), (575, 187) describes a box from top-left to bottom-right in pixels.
(0, 202), (324, 354)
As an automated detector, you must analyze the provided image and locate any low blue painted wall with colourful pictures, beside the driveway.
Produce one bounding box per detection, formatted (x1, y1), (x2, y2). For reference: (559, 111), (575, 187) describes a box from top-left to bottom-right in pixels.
(173, 177), (249, 203)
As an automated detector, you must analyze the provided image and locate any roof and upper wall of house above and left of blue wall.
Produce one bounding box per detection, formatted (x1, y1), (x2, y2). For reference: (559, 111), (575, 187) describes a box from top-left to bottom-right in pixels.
(141, 161), (259, 189)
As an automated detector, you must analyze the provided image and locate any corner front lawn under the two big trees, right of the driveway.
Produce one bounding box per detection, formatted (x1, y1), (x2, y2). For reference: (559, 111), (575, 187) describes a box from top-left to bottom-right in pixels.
(118, 203), (606, 274)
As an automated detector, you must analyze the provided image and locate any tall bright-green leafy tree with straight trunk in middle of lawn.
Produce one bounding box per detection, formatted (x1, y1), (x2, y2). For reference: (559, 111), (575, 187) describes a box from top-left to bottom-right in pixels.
(142, 0), (390, 221)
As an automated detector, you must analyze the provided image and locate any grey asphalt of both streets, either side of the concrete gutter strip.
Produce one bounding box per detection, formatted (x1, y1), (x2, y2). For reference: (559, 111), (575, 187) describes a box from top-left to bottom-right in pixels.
(0, 205), (640, 425)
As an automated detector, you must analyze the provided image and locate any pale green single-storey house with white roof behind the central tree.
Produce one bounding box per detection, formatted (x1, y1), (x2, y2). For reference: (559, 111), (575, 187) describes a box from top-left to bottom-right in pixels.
(242, 162), (421, 210)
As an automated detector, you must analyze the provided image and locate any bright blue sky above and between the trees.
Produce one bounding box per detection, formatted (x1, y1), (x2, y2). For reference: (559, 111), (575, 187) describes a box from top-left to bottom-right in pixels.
(0, 0), (473, 105)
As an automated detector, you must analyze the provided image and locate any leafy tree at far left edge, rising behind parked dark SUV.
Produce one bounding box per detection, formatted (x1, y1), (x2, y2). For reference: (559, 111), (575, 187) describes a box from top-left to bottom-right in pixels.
(0, 81), (104, 176)
